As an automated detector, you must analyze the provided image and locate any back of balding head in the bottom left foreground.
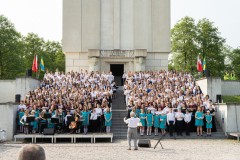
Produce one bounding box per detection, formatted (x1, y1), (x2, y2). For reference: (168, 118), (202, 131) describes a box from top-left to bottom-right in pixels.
(18, 144), (46, 160)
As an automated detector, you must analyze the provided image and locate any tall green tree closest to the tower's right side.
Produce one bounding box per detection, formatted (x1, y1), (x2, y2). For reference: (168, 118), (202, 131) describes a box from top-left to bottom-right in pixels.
(171, 17), (198, 72)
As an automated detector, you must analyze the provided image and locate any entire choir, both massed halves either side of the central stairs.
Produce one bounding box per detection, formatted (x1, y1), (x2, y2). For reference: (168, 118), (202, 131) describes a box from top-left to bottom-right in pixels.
(17, 70), (216, 136)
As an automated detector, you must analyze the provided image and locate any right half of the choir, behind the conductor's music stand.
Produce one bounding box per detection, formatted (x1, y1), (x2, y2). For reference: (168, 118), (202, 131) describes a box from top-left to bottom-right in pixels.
(122, 71), (216, 136)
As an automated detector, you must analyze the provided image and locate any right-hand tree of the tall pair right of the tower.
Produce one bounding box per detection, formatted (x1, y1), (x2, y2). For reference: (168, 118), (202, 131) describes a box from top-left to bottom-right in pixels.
(197, 18), (225, 77)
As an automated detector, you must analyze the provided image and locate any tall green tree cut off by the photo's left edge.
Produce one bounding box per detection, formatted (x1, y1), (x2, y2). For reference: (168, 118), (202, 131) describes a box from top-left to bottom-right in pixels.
(0, 15), (24, 79)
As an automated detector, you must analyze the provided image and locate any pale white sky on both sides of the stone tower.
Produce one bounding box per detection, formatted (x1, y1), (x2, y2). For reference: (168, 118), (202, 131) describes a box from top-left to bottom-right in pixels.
(0, 0), (240, 48)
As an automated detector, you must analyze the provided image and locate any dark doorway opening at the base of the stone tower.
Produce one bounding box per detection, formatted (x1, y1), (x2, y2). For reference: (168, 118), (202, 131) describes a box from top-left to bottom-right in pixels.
(110, 64), (124, 85)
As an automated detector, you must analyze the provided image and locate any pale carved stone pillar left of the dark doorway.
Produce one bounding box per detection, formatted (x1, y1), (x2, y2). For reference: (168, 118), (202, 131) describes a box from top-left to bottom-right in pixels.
(88, 49), (100, 71)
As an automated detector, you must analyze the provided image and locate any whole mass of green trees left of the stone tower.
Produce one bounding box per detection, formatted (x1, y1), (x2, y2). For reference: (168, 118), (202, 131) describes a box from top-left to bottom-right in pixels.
(0, 15), (65, 79)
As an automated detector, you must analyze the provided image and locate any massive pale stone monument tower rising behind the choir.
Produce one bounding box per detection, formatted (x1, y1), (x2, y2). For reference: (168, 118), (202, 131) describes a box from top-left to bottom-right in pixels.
(62, 0), (170, 75)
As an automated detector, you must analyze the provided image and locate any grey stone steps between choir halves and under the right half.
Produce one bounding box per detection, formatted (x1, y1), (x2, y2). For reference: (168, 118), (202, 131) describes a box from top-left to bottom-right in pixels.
(111, 86), (226, 139)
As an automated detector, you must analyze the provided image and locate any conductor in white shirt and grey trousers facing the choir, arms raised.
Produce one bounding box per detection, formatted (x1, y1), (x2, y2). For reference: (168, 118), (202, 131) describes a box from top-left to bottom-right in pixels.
(123, 113), (140, 150)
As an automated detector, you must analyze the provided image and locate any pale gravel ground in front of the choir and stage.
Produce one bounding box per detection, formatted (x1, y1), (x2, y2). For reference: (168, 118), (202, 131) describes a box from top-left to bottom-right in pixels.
(0, 139), (240, 160)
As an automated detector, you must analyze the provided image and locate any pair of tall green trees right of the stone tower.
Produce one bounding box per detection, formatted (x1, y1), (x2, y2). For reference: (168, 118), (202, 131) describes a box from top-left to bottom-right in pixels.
(171, 17), (225, 77)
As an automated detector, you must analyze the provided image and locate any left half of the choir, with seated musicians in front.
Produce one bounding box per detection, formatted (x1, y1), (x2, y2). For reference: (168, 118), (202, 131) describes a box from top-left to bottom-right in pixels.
(17, 70), (116, 134)
